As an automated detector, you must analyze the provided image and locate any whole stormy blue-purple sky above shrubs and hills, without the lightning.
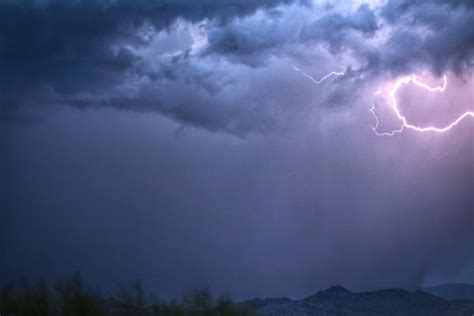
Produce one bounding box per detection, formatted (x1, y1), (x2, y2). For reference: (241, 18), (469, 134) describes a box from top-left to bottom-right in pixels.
(0, 0), (474, 299)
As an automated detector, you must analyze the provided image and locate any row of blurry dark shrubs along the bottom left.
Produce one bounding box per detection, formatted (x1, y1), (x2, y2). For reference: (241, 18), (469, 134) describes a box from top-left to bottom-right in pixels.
(0, 273), (255, 316)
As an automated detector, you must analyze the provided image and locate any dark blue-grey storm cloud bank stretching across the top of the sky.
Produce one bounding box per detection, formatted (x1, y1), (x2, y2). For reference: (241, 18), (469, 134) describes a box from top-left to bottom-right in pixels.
(0, 0), (474, 134)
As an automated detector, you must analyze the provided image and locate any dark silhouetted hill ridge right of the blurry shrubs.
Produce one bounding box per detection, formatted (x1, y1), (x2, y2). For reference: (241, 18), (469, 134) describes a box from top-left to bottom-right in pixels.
(246, 286), (474, 316)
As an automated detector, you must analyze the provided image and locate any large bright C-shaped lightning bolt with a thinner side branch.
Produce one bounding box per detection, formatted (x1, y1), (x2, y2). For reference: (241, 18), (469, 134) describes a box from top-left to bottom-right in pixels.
(370, 75), (474, 136)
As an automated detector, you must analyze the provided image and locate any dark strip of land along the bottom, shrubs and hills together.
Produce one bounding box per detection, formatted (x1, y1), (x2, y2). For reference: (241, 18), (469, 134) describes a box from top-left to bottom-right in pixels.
(0, 273), (474, 316)
